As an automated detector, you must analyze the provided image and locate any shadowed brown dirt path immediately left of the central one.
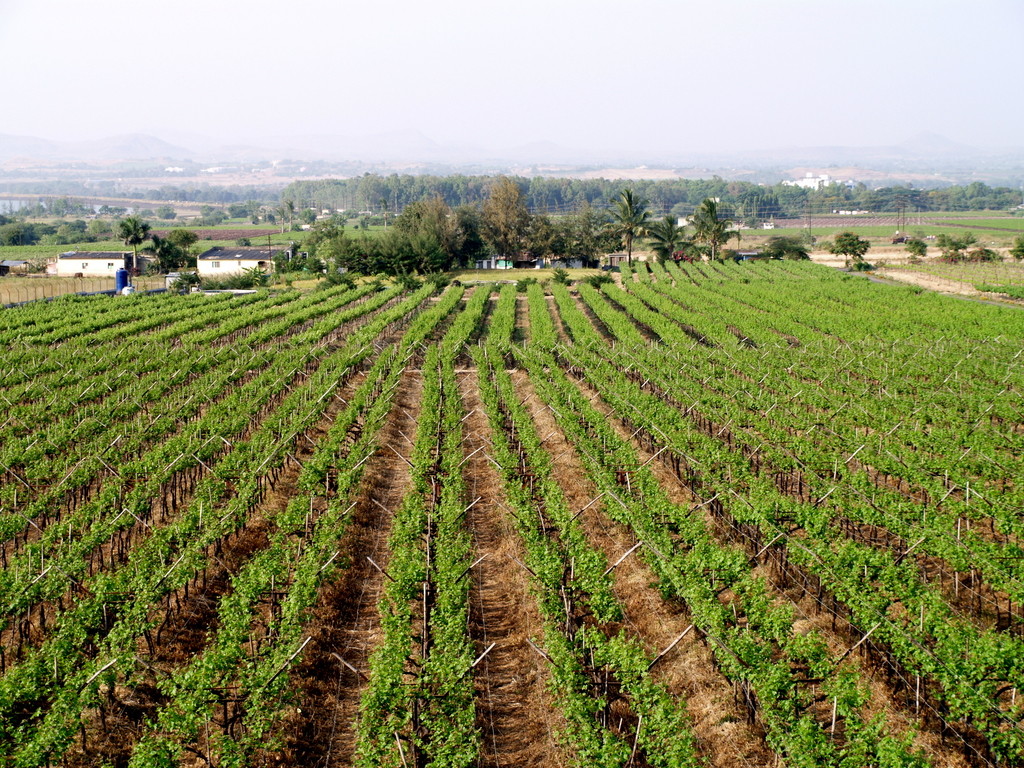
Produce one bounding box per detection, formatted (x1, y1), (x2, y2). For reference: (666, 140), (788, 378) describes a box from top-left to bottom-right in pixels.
(280, 372), (422, 768)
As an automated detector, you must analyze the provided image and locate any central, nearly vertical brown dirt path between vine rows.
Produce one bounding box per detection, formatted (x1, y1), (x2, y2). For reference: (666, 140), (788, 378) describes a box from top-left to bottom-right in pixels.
(460, 372), (565, 768)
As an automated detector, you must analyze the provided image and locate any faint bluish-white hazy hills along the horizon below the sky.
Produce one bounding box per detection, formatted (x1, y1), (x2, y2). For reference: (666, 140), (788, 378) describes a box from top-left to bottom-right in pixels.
(0, 129), (1024, 185)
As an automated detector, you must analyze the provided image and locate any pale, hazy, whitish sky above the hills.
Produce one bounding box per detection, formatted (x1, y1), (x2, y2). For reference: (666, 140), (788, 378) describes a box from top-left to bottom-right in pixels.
(0, 0), (1024, 153)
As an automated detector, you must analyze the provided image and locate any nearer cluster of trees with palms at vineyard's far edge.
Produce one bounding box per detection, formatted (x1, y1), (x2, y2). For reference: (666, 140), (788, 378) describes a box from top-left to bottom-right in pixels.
(303, 177), (807, 275)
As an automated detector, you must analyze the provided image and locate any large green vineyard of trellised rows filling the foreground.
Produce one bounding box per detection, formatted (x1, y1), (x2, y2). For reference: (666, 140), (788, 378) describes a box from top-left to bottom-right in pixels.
(0, 262), (1024, 768)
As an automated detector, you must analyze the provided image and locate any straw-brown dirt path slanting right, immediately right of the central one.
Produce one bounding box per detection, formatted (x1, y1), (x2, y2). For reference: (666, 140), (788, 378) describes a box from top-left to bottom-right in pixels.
(515, 374), (775, 768)
